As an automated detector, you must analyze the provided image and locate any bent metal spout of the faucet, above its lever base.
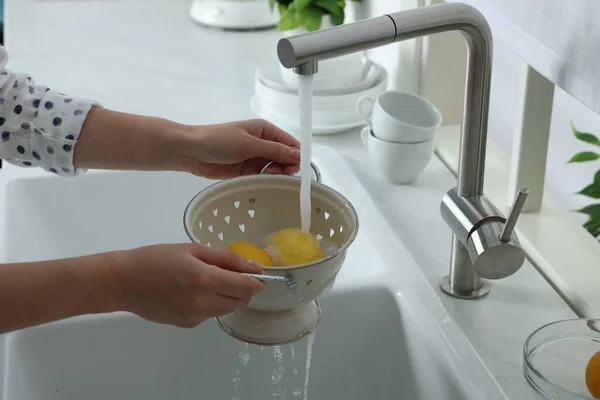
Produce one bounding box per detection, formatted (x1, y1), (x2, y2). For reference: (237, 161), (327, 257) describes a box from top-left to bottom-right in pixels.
(277, 3), (492, 197)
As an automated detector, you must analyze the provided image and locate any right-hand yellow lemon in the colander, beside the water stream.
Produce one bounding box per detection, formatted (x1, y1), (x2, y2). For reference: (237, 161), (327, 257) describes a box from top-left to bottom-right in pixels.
(264, 228), (325, 266)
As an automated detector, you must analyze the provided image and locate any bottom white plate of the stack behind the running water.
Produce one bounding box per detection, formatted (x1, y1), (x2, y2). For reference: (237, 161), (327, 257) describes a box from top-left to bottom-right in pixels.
(250, 95), (365, 136)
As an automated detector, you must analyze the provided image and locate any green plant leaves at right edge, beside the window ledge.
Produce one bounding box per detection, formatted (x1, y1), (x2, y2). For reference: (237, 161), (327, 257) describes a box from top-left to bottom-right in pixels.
(569, 122), (600, 240)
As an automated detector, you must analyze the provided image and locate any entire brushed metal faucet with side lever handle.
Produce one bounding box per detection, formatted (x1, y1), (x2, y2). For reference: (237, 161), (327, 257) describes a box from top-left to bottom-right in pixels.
(277, 3), (528, 299)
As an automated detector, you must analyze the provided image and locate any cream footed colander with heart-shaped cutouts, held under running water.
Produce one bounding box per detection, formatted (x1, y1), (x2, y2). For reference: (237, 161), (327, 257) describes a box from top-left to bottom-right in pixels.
(184, 163), (358, 345)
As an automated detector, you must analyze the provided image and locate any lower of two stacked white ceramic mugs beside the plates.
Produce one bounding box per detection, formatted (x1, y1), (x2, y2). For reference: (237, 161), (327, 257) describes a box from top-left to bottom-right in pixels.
(360, 126), (435, 184)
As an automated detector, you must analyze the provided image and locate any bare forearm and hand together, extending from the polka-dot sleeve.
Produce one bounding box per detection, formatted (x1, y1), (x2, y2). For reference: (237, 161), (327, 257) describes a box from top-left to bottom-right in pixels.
(73, 107), (300, 179)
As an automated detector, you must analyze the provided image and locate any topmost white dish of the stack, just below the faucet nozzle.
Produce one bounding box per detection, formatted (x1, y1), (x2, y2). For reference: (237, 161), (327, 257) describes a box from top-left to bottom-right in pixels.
(257, 59), (382, 96)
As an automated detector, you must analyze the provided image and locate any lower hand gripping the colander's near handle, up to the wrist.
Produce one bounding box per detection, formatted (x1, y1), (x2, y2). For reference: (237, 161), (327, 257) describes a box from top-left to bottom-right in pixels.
(115, 244), (263, 328)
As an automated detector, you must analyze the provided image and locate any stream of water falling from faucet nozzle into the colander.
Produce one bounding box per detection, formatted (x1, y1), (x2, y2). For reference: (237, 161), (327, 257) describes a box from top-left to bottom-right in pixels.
(298, 75), (313, 232)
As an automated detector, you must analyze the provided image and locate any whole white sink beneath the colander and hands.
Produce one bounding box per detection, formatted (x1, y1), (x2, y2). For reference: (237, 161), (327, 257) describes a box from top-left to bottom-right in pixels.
(0, 146), (506, 400)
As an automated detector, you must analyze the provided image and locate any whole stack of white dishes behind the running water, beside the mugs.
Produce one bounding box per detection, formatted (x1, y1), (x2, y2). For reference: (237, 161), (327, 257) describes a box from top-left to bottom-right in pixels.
(250, 58), (387, 135)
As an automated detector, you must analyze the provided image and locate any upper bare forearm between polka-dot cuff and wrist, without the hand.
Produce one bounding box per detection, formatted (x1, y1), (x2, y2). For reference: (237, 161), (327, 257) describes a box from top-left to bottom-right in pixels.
(73, 107), (192, 171)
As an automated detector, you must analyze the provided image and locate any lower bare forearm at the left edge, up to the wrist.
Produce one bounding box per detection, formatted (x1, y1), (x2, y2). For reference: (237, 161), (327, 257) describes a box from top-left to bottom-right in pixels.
(0, 252), (121, 333)
